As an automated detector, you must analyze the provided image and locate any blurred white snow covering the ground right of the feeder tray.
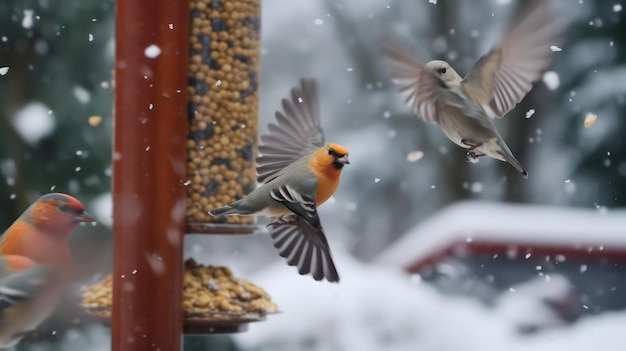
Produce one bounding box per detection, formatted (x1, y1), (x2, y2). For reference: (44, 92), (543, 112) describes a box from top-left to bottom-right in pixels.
(235, 247), (626, 351)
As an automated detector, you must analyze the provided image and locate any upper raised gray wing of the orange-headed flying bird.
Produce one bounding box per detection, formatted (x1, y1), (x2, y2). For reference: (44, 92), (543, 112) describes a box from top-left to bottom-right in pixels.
(257, 78), (324, 182)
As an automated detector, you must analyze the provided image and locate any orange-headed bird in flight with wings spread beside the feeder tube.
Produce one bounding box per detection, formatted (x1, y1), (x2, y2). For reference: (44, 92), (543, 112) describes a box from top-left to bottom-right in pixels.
(209, 79), (350, 282)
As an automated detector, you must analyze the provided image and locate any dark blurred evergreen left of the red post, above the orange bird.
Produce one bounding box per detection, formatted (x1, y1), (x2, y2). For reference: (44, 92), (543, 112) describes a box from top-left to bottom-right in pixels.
(0, 0), (114, 228)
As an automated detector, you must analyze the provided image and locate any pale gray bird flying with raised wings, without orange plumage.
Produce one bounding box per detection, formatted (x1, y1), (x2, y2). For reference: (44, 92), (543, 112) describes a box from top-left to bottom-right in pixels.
(383, 0), (562, 178)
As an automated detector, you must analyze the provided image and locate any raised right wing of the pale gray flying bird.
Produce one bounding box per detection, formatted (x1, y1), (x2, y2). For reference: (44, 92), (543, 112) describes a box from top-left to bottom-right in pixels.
(462, 0), (563, 119)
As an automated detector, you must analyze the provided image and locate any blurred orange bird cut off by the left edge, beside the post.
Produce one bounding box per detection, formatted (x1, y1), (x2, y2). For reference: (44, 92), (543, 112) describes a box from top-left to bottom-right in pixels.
(0, 193), (94, 348)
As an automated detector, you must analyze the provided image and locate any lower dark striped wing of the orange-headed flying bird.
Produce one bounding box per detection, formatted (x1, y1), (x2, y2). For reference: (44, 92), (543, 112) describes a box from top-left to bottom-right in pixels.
(267, 215), (339, 282)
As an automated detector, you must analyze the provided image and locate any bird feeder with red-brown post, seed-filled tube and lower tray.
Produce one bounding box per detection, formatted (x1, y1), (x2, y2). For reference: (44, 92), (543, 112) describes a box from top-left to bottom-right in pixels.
(103, 0), (264, 351)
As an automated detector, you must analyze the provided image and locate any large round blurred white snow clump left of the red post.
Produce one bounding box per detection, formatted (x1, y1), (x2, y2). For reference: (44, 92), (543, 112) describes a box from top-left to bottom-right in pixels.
(13, 102), (56, 145)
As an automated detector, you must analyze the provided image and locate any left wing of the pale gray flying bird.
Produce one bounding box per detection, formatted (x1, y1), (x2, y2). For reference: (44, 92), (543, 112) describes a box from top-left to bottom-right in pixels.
(383, 39), (472, 123)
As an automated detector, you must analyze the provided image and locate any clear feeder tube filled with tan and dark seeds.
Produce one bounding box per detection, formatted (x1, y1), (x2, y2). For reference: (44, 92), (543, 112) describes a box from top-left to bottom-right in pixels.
(186, 0), (261, 234)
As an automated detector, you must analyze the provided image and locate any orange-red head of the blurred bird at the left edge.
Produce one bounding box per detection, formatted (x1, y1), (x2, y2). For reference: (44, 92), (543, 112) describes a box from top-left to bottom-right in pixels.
(23, 193), (95, 235)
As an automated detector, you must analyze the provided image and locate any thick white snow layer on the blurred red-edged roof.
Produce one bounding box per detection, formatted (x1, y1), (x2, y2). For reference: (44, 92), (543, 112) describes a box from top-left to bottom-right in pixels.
(376, 201), (626, 267)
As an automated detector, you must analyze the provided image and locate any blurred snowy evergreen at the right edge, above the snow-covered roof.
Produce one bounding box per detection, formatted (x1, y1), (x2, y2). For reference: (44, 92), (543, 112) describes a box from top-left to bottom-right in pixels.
(559, 1), (626, 207)
